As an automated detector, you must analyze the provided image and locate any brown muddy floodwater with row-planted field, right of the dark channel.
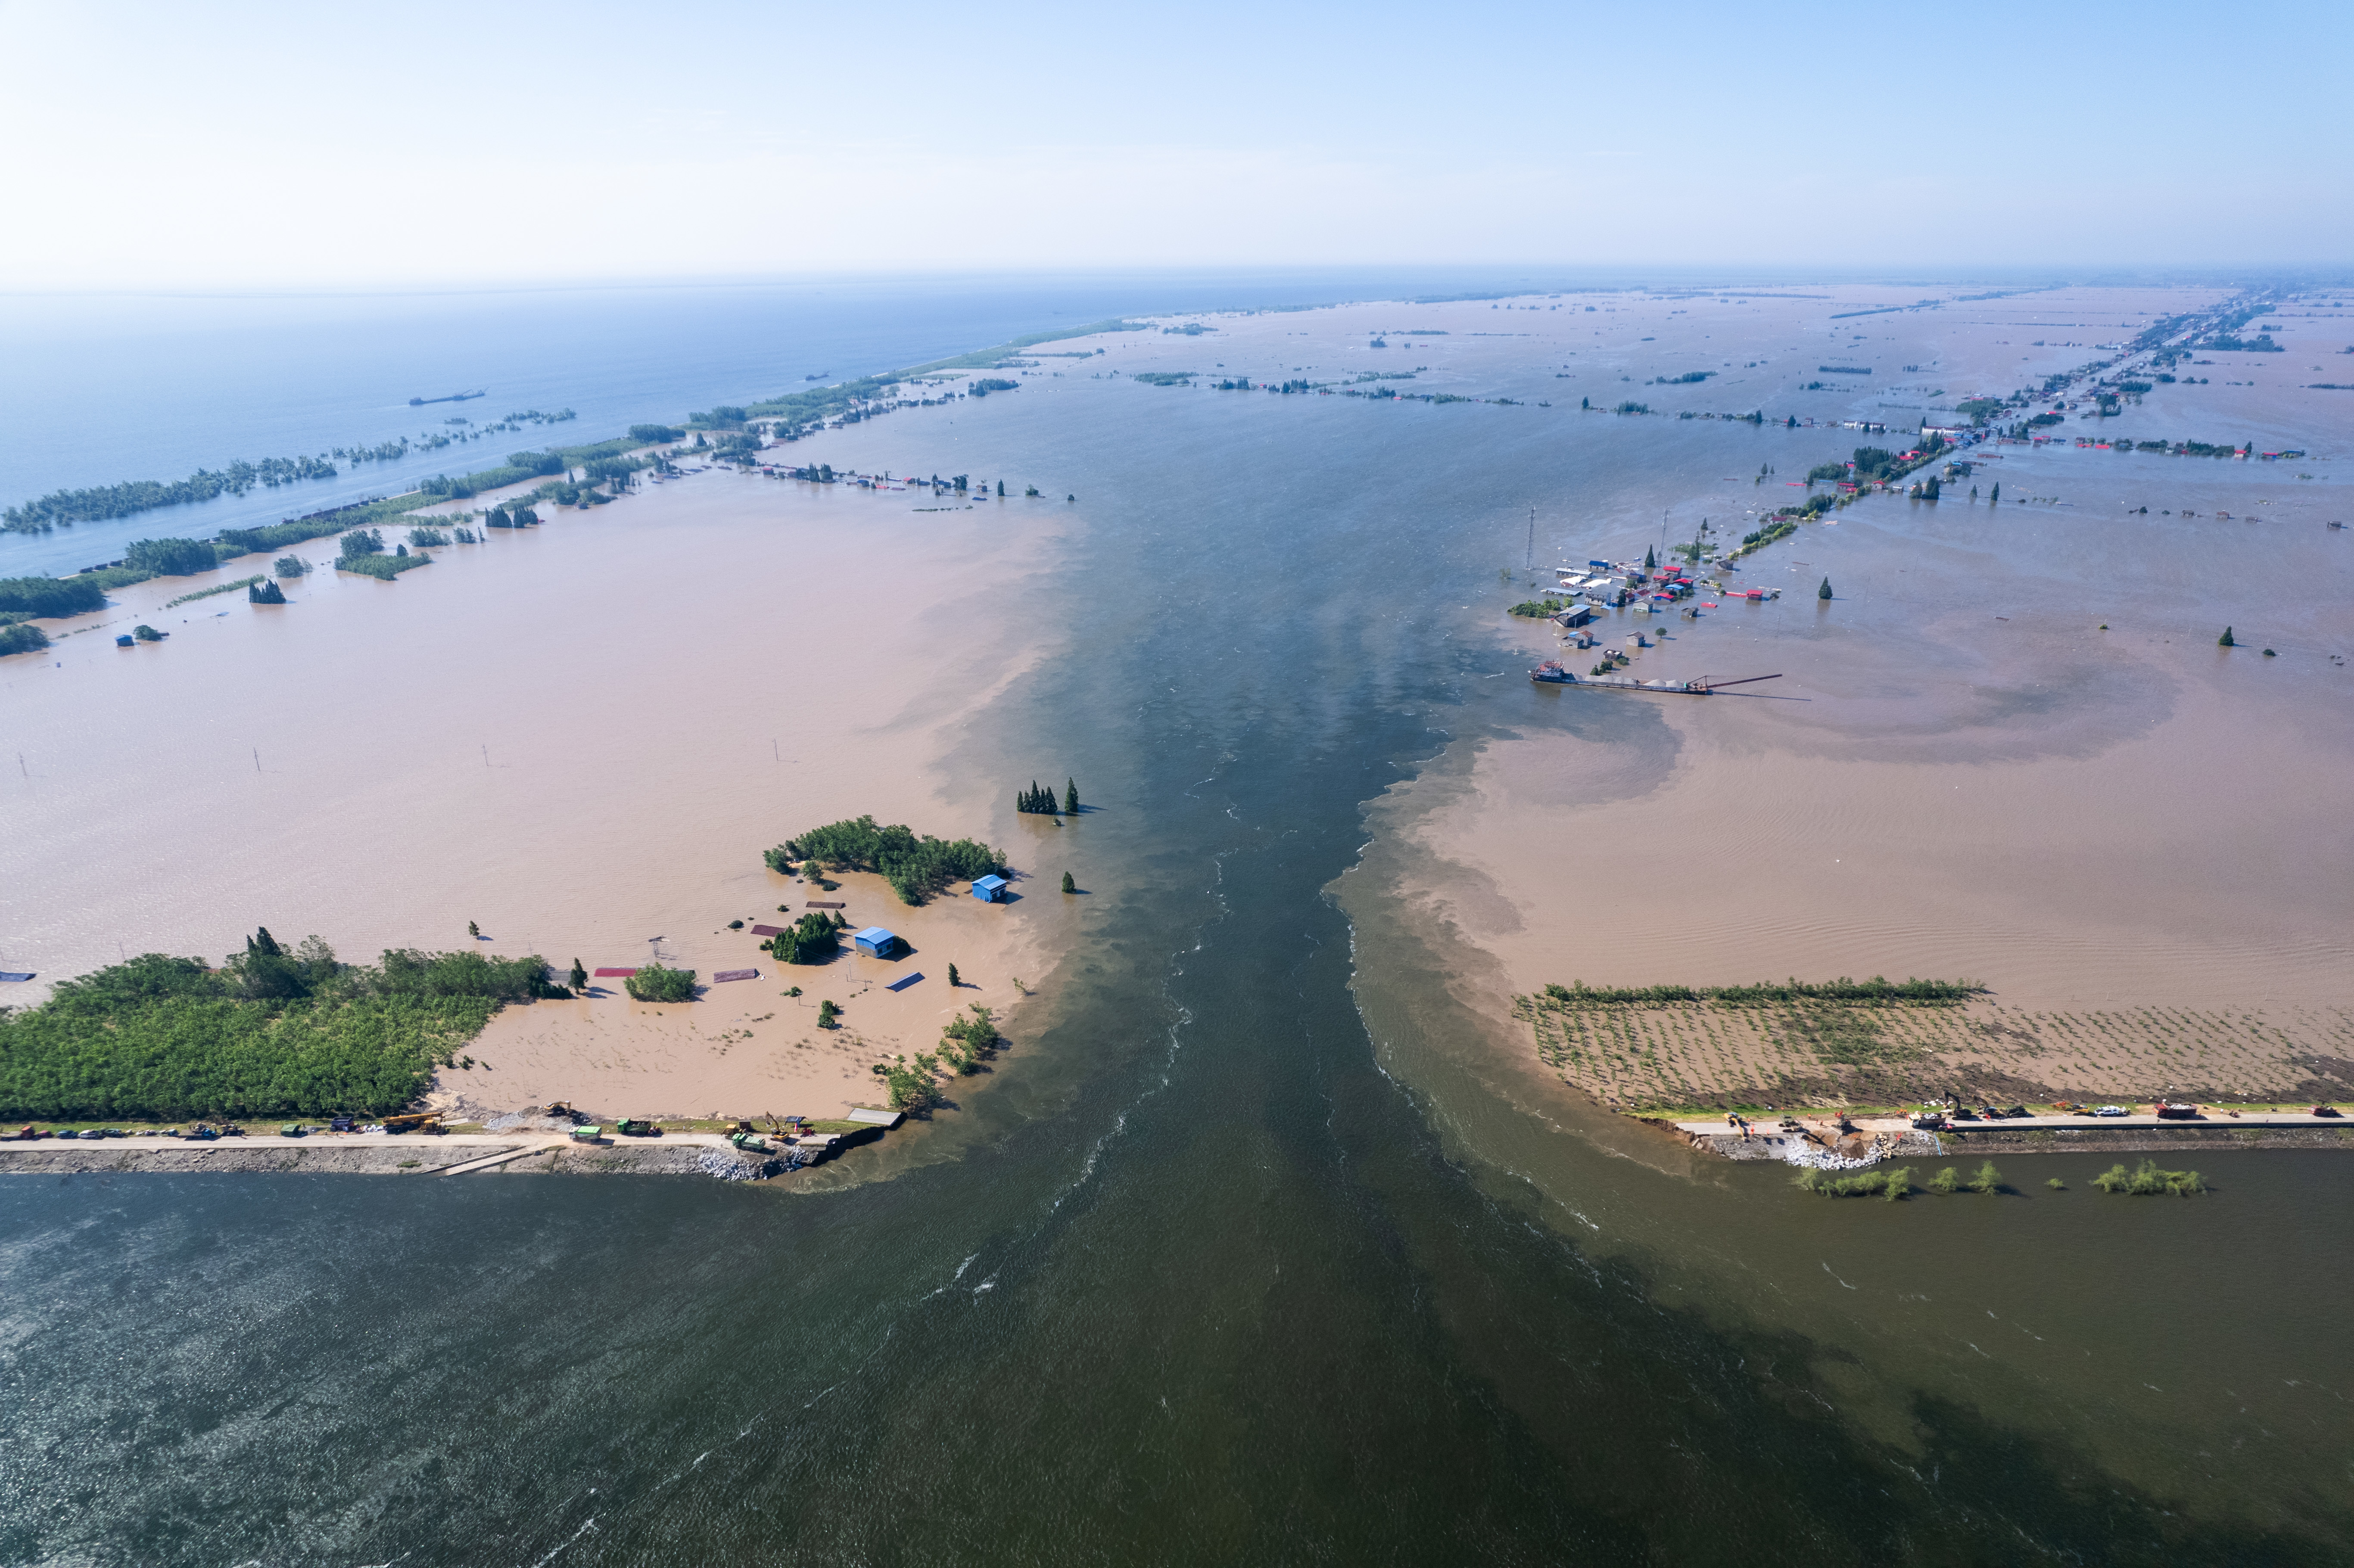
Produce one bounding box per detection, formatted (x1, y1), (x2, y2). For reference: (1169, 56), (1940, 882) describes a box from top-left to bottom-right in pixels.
(1354, 464), (2354, 1125)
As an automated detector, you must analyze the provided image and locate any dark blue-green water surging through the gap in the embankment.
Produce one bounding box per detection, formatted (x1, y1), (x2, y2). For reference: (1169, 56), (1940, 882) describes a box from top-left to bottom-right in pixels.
(0, 287), (2354, 1563)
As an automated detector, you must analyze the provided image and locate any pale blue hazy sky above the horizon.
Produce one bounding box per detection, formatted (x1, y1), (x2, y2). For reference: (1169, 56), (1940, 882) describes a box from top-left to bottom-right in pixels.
(0, 0), (2354, 287)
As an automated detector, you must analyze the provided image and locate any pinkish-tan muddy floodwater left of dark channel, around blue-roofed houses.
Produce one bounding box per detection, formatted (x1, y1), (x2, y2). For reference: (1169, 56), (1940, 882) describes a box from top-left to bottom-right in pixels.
(0, 459), (1076, 1118)
